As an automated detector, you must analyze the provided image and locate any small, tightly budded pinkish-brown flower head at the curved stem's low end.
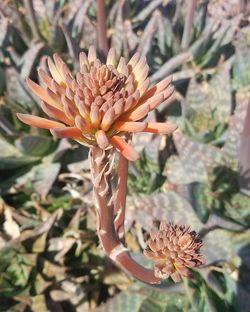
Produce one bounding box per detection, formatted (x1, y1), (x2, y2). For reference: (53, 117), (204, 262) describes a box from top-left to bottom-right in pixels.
(144, 222), (205, 282)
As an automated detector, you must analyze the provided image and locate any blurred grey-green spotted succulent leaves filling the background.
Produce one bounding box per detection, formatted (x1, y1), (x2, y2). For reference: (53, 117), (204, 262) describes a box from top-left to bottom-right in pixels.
(0, 0), (250, 312)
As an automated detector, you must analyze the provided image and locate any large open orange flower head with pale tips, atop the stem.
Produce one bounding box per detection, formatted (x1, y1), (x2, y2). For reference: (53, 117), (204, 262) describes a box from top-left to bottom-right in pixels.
(17, 47), (176, 161)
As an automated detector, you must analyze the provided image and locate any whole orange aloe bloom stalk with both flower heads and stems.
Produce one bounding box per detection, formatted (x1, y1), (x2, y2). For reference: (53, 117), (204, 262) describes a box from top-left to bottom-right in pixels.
(17, 47), (204, 283)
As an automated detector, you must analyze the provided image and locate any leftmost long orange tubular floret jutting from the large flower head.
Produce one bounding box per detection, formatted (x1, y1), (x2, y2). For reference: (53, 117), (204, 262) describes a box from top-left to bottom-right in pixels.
(17, 113), (65, 129)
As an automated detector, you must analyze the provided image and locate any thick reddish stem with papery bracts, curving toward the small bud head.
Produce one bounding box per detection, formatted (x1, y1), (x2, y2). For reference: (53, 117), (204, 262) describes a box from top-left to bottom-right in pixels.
(90, 147), (160, 284)
